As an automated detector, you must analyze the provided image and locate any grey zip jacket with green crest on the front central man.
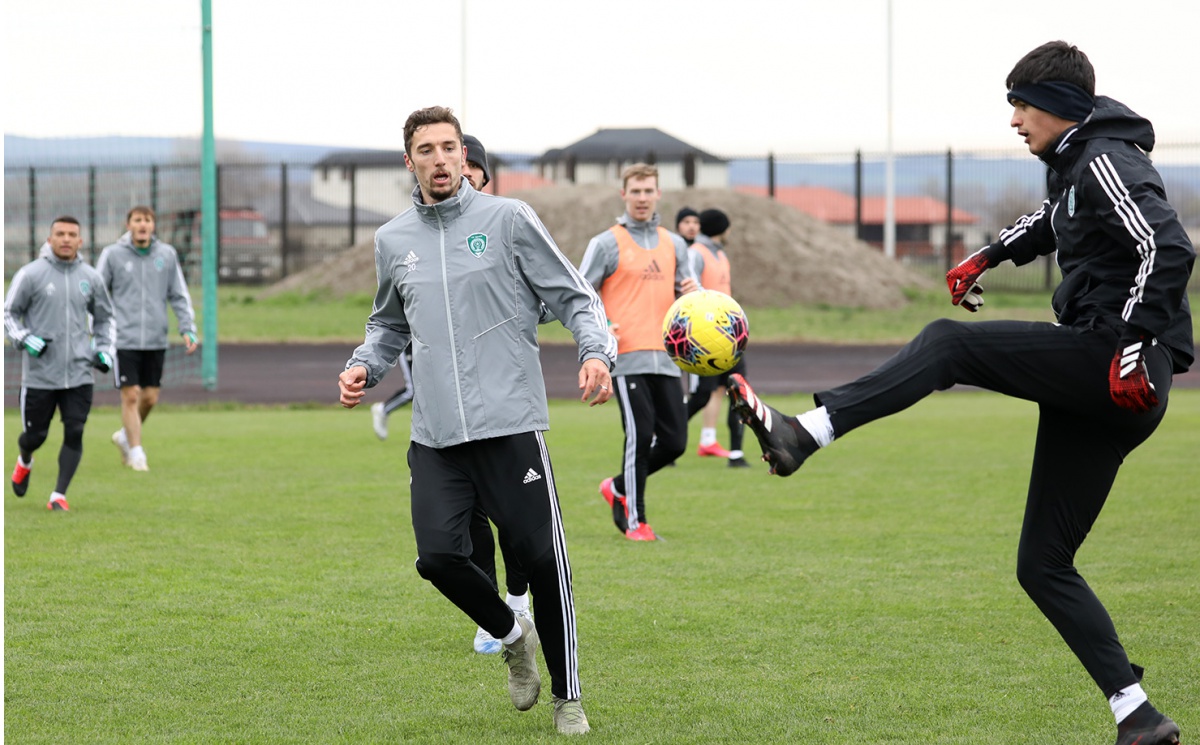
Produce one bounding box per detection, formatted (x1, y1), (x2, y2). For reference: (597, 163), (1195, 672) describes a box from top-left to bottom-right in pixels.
(346, 180), (617, 447)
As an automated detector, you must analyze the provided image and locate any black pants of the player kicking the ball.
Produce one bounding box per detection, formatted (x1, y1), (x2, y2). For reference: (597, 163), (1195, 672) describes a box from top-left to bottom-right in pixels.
(815, 319), (1172, 697)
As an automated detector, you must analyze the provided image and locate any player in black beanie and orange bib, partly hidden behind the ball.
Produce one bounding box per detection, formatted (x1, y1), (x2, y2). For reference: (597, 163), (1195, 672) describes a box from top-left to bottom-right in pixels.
(688, 209), (750, 468)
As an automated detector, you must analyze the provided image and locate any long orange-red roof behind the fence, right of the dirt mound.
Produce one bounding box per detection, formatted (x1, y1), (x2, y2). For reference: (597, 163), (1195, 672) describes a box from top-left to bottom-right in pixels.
(737, 186), (979, 226)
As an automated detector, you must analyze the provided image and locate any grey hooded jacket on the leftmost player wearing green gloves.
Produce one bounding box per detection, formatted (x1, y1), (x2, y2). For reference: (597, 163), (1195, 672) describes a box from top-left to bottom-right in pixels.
(4, 245), (115, 390)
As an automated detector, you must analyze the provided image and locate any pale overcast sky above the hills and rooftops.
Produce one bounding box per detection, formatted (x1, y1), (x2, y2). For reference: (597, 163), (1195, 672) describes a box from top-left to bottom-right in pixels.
(4, 0), (1200, 155)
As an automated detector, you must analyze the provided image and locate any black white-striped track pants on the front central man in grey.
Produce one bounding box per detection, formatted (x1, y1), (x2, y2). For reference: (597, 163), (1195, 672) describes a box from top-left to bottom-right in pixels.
(408, 432), (580, 698)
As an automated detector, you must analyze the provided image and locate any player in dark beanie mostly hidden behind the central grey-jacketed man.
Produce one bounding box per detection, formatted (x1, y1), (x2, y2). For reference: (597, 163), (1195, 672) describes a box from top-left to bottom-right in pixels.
(371, 134), (533, 655)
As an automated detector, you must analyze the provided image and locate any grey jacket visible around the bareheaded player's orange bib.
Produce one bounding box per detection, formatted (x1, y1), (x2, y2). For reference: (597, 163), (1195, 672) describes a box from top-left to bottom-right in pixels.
(580, 212), (700, 378)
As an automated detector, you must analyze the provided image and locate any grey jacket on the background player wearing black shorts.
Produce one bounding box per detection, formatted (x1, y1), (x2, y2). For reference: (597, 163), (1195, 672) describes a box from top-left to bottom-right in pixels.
(96, 233), (196, 350)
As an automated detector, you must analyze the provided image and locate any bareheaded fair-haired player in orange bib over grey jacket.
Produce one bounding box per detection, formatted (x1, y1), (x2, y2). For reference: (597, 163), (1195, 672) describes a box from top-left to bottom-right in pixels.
(580, 163), (700, 541)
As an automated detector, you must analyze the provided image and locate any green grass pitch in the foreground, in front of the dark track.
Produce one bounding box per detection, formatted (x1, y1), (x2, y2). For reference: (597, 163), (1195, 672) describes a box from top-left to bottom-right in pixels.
(5, 391), (1200, 745)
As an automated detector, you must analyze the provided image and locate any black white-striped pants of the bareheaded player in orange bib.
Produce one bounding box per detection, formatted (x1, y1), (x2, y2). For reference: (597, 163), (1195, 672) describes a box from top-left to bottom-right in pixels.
(612, 374), (688, 529)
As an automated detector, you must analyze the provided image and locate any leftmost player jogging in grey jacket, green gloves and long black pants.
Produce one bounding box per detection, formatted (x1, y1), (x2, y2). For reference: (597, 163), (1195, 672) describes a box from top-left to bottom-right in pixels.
(4, 216), (114, 511)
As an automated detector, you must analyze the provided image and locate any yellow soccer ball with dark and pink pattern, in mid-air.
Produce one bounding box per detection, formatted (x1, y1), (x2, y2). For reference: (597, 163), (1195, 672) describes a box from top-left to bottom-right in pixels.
(662, 290), (750, 375)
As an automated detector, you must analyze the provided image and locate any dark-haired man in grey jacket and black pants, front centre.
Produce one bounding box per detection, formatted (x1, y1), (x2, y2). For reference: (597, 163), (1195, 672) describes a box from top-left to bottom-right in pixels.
(338, 107), (617, 734)
